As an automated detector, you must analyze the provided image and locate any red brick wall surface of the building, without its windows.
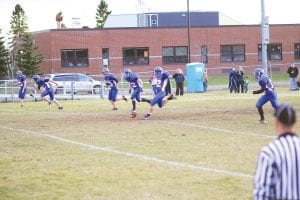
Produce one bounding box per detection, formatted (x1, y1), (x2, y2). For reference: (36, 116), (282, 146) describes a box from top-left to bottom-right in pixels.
(35, 24), (300, 74)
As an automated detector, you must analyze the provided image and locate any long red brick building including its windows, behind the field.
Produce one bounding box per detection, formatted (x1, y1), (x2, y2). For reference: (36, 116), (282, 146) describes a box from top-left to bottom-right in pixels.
(34, 24), (300, 74)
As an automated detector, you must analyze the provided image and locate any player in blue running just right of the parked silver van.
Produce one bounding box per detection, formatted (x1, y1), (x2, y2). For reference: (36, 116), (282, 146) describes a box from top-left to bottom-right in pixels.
(103, 68), (127, 110)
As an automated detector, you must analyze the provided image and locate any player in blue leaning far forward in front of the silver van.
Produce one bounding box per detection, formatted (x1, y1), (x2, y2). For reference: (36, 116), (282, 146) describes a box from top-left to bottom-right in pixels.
(33, 75), (63, 110)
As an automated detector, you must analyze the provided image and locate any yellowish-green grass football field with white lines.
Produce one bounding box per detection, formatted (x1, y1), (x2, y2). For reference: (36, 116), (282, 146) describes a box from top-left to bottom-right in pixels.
(0, 87), (300, 200)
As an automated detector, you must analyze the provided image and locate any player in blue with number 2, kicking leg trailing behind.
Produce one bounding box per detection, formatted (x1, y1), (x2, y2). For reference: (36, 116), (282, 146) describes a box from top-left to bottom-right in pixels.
(144, 67), (176, 120)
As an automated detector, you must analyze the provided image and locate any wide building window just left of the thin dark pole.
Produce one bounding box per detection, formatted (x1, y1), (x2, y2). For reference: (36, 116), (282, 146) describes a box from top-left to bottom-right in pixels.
(163, 47), (188, 64)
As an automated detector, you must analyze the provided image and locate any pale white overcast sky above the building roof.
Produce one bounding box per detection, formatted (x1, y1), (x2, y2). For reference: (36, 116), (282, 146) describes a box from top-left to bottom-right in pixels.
(0, 0), (300, 33)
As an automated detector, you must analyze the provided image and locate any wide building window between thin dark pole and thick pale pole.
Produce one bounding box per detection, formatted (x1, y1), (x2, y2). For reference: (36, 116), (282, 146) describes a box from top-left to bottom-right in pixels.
(220, 44), (246, 62)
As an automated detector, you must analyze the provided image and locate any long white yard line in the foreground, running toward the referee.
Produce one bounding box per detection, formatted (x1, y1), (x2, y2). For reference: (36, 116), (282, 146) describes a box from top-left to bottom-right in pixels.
(0, 125), (253, 179)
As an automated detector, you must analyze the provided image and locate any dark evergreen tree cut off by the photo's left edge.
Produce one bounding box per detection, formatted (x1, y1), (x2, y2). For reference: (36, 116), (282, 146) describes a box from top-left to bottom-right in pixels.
(0, 30), (9, 79)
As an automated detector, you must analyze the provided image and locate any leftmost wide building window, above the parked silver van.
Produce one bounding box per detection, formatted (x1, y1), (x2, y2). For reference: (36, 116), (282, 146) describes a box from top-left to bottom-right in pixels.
(61, 49), (89, 67)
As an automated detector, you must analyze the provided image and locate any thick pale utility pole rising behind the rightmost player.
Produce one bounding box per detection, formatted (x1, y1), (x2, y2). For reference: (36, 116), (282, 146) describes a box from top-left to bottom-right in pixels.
(261, 0), (270, 74)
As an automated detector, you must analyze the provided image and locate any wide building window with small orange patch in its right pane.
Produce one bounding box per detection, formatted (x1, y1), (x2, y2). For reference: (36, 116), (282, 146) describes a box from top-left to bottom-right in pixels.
(123, 47), (149, 65)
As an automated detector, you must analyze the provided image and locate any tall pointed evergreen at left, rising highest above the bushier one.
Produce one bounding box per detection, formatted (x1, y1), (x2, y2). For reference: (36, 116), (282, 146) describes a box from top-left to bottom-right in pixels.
(9, 4), (28, 77)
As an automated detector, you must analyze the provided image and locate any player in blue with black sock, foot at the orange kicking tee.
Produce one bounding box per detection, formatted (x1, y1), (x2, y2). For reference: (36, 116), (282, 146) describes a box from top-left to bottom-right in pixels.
(124, 69), (150, 118)
